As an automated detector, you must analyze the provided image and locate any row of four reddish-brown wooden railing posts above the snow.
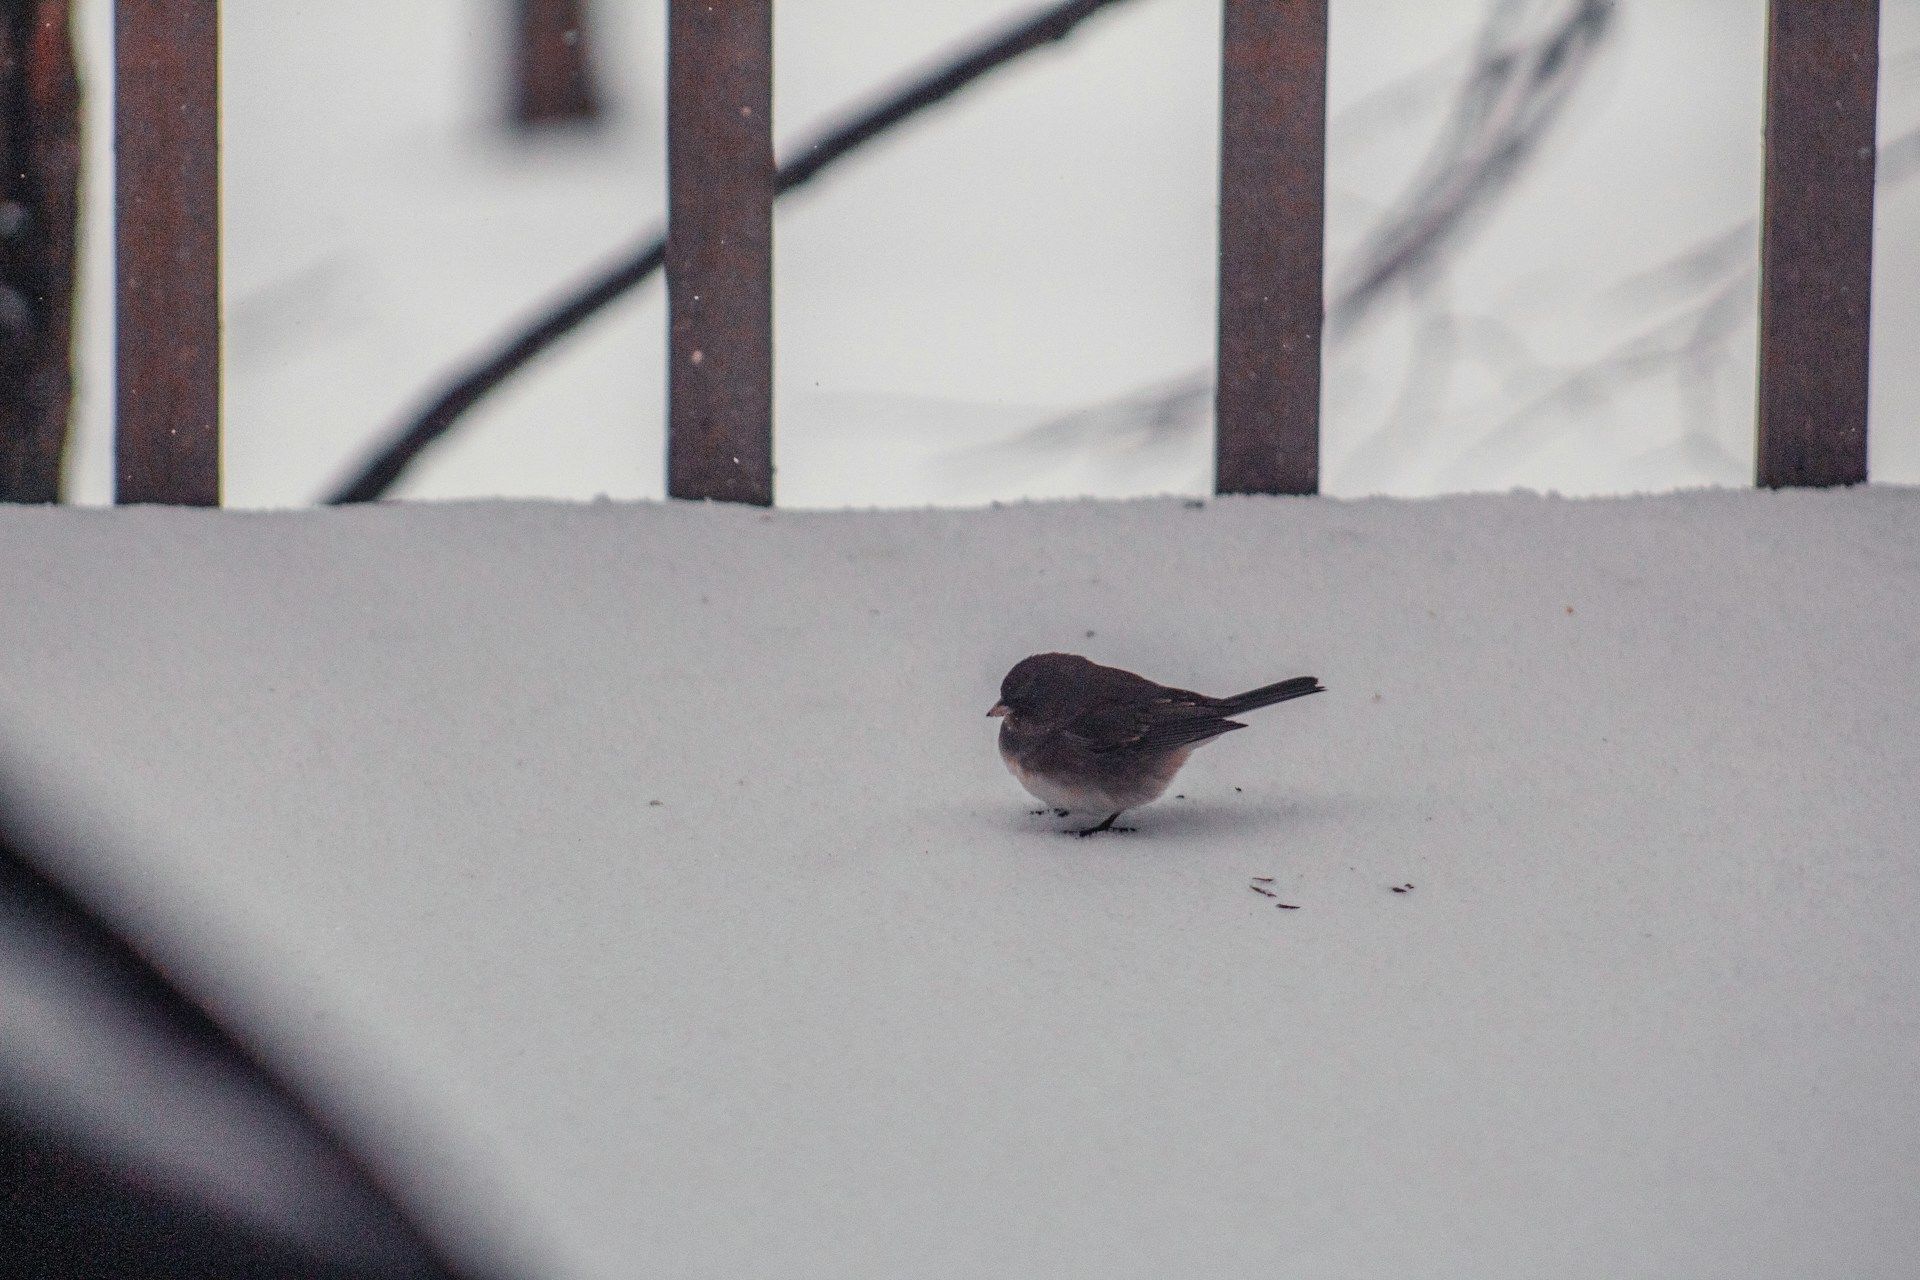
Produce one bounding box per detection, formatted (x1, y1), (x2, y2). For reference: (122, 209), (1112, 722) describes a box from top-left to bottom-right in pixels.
(115, 0), (1880, 505)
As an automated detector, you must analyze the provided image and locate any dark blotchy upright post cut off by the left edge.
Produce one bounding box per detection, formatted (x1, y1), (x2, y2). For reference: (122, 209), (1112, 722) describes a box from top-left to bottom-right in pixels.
(0, 0), (81, 503)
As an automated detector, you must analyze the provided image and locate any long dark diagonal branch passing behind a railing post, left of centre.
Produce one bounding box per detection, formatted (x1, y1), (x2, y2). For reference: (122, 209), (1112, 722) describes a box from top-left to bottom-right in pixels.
(326, 0), (1121, 505)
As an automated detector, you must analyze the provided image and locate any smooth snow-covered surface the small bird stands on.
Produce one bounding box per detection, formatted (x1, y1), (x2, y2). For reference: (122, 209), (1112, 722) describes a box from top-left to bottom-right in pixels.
(0, 487), (1920, 1280)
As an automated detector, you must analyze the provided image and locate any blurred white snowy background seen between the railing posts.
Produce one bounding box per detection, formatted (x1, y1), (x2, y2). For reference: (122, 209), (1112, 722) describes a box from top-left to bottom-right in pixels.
(52, 0), (1920, 507)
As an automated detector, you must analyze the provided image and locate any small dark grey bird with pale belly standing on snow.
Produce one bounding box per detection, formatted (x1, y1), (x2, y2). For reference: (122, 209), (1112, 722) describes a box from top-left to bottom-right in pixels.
(987, 652), (1325, 835)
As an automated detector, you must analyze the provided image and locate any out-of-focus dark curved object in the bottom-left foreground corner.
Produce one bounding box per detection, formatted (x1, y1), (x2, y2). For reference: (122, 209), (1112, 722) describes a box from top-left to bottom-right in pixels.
(0, 779), (503, 1280)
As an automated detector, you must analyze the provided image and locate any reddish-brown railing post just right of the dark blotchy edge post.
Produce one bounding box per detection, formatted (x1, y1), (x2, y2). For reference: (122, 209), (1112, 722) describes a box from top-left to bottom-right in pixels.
(113, 0), (221, 507)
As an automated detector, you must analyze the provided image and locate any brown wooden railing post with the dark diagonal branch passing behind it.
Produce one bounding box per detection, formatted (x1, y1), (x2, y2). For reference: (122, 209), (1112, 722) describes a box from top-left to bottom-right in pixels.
(666, 0), (774, 507)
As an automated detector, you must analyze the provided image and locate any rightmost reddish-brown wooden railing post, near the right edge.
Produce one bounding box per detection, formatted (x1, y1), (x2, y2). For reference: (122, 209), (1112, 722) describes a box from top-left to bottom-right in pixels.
(1757, 0), (1880, 487)
